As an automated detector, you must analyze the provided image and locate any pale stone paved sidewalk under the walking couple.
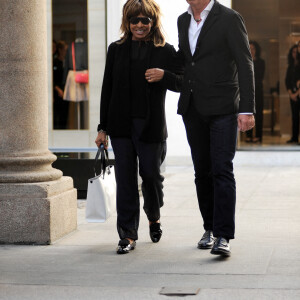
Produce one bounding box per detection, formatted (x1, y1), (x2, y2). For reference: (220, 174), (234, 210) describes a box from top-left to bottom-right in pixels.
(0, 154), (300, 300)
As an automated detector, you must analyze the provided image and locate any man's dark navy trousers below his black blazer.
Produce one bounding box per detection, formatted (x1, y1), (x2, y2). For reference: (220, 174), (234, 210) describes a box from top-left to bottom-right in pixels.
(183, 105), (237, 239)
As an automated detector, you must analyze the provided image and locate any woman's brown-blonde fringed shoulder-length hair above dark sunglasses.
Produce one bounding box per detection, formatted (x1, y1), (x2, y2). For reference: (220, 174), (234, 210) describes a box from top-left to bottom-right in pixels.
(120, 0), (166, 47)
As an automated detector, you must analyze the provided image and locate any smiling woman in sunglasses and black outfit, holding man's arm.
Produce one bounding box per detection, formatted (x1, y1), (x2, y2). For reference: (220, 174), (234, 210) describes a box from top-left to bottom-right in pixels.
(95, 0), (182, 254)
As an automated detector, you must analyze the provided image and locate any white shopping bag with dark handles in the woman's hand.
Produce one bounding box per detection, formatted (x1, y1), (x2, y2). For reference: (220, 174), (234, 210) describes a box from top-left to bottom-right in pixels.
(86, 147), (116, 223)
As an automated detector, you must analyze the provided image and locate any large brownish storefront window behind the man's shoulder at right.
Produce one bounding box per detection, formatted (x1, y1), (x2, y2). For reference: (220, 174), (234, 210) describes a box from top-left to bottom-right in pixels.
(232, 0), (300, 150)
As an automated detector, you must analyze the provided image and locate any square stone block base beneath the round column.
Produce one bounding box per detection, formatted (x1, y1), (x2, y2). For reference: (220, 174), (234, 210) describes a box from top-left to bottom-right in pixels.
(0, 177), (77, 245)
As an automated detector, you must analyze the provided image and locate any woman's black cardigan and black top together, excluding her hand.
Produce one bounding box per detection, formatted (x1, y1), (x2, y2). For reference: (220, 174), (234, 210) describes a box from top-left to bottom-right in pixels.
(97, 39), (183, 143)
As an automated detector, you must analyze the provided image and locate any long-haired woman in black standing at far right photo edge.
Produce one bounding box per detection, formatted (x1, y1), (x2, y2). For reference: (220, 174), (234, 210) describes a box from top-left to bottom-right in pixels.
(285, 45), (300, 143)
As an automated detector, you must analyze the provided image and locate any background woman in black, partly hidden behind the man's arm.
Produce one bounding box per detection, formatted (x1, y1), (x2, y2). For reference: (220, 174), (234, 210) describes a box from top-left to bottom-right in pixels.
(246, 41), (265, 143)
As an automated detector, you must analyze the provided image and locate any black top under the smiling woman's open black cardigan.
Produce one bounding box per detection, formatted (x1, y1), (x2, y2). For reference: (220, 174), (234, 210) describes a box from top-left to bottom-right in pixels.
(130, 41), (150, 118)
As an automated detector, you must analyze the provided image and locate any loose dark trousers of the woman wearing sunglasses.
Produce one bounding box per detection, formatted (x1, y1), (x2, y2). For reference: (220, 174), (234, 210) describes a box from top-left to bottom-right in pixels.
(111, 119), (166, 240)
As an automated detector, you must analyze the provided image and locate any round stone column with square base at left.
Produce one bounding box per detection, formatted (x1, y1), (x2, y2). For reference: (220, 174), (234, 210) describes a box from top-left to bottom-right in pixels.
(0, 0), (77, 244)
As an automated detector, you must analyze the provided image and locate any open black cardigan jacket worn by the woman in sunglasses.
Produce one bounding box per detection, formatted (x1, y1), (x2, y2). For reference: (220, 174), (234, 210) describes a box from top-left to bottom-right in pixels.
(98, 39), (183, 142)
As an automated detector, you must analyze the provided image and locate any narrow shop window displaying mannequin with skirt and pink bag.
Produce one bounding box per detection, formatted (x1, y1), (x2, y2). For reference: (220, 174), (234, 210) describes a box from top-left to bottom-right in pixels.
(52, 0), (89, 130)
